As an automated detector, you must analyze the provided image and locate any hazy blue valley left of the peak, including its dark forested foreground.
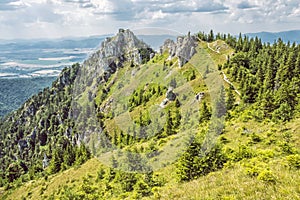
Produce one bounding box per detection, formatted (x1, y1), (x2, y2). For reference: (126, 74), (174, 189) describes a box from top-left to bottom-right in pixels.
(0, 36), (105, 117)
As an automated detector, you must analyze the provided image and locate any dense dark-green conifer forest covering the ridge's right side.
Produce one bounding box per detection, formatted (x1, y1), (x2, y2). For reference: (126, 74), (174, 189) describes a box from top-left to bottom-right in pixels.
(222, 36), (300, 122)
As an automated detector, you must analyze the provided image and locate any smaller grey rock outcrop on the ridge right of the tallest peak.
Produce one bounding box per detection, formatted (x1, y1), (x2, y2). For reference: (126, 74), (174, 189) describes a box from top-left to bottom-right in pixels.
(160, 33), (197, 67)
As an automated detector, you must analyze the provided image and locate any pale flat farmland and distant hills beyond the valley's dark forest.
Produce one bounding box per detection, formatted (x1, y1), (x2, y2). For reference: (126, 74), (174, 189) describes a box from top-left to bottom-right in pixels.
(0, 36), (105, 78)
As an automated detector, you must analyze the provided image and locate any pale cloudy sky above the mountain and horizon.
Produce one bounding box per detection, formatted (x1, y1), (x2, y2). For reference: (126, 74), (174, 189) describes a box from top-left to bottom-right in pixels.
(0, 0), (300, 39)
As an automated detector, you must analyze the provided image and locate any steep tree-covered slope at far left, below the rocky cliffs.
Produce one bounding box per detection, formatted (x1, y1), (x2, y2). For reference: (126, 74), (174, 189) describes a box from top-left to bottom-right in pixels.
(0, 64), (90, 191)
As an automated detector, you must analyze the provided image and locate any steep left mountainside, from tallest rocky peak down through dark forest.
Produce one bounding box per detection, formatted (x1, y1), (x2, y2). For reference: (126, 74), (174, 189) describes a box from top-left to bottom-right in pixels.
(0, 27), (152, 187)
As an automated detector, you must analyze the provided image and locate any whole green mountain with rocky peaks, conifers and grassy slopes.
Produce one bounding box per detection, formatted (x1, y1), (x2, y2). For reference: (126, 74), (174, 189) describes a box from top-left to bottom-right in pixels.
(0, 29), (300, 199)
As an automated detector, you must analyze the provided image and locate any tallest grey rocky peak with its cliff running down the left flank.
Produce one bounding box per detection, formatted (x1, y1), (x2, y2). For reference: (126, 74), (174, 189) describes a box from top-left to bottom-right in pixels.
(71, 29), (154, 141)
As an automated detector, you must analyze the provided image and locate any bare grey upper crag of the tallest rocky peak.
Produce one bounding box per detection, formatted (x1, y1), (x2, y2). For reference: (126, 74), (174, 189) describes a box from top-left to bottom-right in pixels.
(83, 29), (153, 83)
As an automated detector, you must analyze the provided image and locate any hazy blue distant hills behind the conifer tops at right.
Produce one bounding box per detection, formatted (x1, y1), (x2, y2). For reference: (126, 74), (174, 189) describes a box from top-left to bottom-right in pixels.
(245, 30), (300, 43)
